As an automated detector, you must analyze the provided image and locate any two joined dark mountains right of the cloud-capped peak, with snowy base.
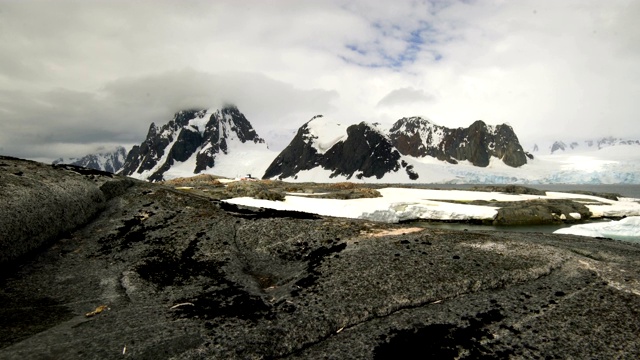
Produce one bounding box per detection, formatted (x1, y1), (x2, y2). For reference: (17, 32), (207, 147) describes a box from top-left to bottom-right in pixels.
(264, 115), (533, 182)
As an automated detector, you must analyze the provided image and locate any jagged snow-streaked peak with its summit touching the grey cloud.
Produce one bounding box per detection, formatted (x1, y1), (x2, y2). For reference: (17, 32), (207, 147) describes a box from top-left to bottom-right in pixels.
(122, 106), (273, 181)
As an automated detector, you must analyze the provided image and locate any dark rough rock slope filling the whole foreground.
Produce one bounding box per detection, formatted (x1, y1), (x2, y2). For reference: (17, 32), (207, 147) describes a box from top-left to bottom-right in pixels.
(0, 157), (640, 359)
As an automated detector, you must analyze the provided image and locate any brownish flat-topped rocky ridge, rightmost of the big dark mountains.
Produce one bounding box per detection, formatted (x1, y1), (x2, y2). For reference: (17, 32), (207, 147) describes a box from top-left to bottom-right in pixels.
(389, 117), (533, 167)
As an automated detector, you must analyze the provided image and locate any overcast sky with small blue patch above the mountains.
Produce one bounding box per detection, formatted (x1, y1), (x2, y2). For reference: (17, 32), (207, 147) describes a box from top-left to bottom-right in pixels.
(0, 0), (640, 161)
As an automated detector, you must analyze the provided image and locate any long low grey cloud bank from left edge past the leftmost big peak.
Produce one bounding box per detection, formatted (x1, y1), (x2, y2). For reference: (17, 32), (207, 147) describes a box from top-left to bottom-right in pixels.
(0, 69), (338, 158)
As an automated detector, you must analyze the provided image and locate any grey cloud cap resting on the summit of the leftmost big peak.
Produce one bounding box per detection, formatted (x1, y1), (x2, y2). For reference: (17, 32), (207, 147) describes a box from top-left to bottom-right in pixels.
(103, 69), (338, 121)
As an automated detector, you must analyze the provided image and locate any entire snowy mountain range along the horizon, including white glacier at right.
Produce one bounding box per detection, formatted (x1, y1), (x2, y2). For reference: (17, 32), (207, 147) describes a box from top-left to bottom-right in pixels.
(48, 106), (640, 183)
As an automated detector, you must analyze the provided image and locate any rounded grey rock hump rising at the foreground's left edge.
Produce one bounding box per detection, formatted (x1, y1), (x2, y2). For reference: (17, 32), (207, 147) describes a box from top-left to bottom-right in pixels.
(0, 156), (130, 264)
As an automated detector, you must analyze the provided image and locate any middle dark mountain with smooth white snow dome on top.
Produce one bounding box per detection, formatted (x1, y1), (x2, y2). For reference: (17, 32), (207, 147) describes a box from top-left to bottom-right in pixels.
(263, 115), (415, 179)
